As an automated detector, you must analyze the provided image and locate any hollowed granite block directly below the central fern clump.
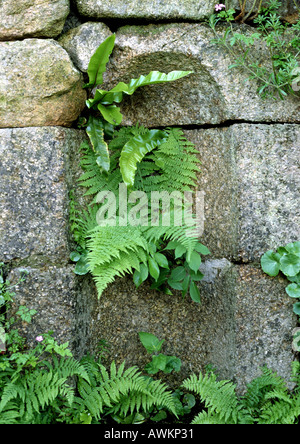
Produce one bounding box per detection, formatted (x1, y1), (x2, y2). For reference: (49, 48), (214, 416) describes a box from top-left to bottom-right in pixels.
(91, 259), (297, 391)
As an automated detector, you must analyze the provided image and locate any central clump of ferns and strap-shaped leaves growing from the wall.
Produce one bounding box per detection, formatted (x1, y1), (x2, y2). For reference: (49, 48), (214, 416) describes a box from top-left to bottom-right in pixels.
(70, 35), (210, 302)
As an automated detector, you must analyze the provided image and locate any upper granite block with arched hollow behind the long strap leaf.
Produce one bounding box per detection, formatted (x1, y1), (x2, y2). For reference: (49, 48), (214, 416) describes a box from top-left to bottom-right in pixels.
(96, 23), (300, 127)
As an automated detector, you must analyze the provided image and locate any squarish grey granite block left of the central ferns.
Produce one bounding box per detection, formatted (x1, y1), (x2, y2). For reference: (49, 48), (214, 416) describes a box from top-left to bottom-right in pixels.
(0, 127), (84, 263)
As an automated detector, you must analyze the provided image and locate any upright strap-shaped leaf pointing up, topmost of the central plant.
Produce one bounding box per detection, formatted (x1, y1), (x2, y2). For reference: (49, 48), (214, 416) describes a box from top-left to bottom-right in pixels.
(84, 34), (116, 88)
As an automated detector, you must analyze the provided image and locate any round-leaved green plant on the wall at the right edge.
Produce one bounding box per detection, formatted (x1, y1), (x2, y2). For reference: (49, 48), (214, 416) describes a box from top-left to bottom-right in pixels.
(261, 242), (300, 351)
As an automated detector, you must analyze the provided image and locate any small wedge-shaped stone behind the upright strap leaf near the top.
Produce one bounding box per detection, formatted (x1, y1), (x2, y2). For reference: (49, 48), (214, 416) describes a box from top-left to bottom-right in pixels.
(58, 22), (112, 72)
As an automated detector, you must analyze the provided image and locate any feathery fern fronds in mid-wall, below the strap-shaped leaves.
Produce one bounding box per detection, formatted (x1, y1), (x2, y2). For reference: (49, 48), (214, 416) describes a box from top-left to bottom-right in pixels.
(72, 125), (203, 296)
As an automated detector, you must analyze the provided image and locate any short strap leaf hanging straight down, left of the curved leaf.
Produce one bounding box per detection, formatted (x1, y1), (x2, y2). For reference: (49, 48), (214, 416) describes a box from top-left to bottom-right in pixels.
(86, 116), (110, 172)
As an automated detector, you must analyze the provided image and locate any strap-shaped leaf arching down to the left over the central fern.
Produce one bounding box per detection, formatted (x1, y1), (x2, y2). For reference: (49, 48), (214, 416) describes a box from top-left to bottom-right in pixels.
(120, 130), (167, 187)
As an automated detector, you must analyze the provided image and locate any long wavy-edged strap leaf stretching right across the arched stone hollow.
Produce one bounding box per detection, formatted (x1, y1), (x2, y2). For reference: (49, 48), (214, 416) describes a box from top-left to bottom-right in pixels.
(87, 71), (193, 108)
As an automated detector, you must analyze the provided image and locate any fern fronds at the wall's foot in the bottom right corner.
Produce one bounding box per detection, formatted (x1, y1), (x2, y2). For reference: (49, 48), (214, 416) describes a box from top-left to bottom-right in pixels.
(183, 363), (300, 424)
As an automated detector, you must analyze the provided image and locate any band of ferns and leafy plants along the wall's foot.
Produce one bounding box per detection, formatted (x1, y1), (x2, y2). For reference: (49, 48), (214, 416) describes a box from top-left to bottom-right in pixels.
(0, 280), (300, 425)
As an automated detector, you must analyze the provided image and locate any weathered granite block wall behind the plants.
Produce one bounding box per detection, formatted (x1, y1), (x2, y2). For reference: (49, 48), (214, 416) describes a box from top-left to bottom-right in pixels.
(0, 0), (300, 388)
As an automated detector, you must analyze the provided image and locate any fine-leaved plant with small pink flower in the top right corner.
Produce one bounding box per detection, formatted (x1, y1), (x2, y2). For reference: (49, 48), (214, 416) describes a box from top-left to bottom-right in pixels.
(209, 0), (300, 99)
